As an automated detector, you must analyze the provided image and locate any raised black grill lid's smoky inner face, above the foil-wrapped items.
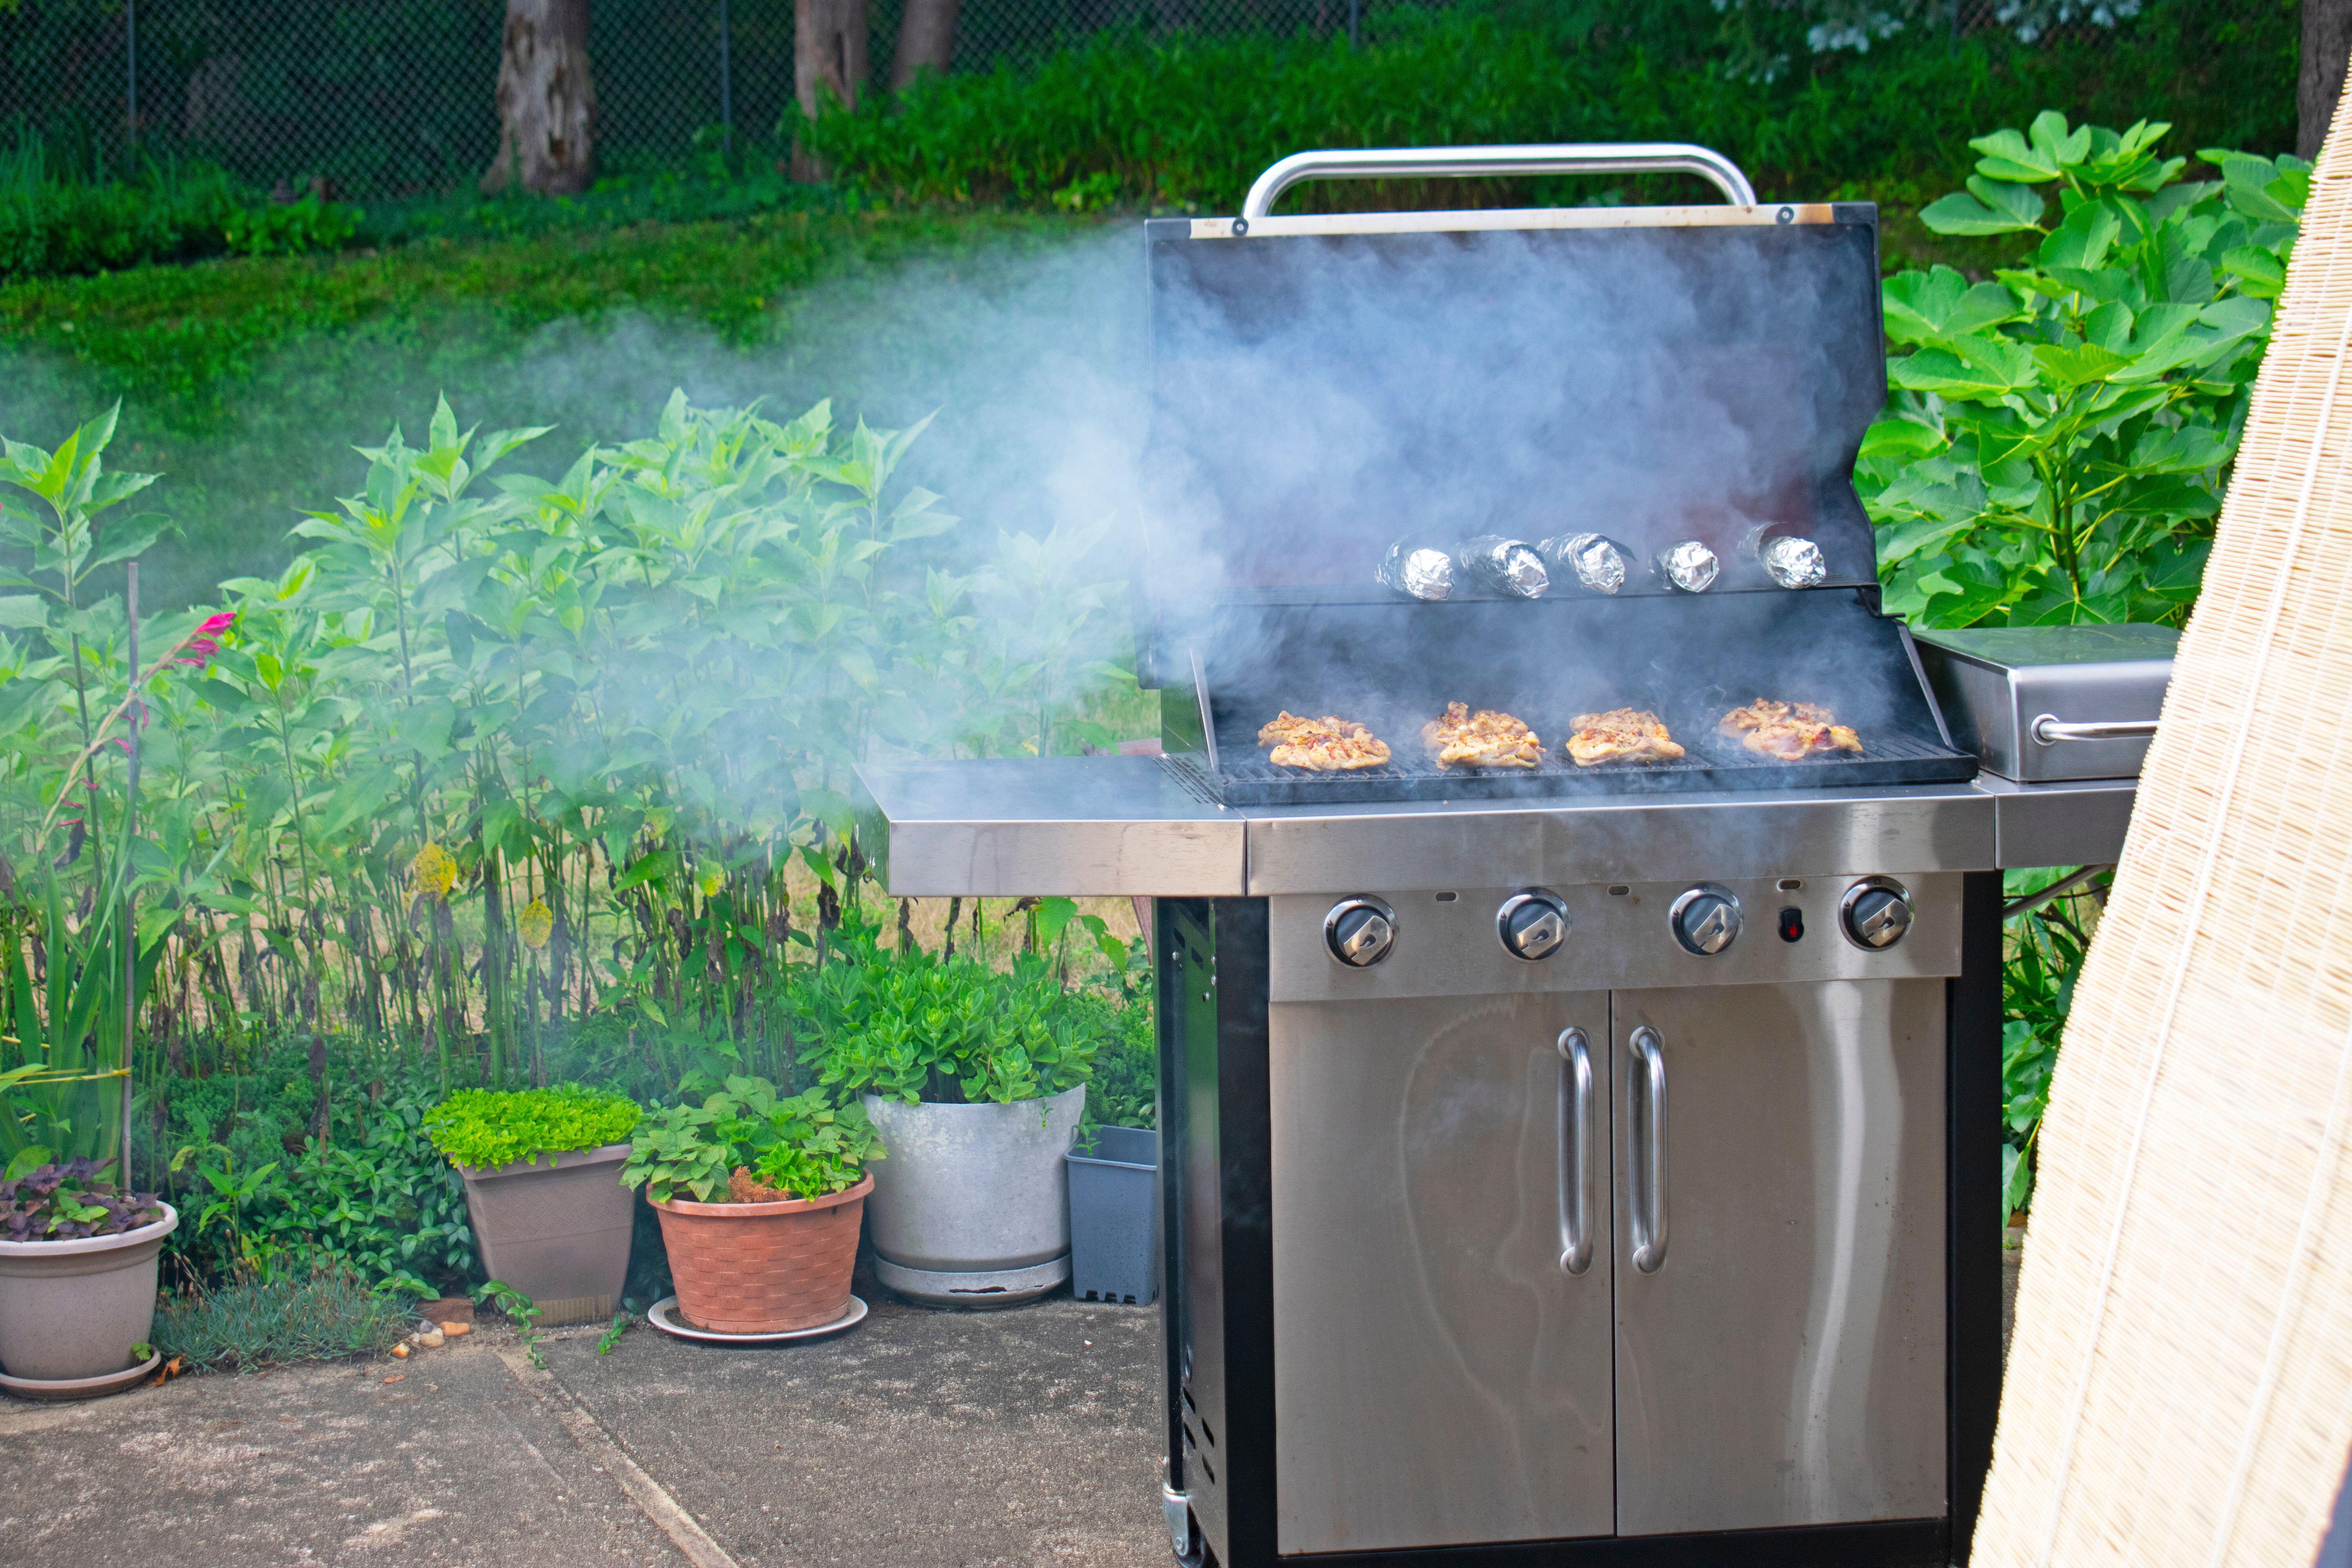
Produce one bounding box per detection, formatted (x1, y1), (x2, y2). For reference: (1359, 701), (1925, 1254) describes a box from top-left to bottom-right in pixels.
(1141, 148), (1886, 672)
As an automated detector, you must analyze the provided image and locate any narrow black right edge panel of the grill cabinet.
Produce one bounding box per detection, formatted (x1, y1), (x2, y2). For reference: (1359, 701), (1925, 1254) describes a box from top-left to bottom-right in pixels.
(1945, 872), (2002, 1563)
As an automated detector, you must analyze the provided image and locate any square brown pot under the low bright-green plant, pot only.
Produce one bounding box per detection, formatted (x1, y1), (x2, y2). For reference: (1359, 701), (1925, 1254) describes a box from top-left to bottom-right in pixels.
(456, 1143), (637, 1328)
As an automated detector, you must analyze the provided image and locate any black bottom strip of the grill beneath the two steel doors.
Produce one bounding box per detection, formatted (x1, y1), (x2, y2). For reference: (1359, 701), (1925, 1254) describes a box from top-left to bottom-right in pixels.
(1282, 1519), (1950, 1568)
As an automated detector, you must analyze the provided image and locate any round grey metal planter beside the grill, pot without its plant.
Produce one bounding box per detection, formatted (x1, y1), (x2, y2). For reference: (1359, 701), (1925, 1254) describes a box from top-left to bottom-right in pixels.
(866, 1089), (1087, 1307)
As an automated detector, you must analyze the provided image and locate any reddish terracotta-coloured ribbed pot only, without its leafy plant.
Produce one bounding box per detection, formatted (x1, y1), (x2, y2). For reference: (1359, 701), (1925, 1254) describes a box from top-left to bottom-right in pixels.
(654, 1176), (875, 1333)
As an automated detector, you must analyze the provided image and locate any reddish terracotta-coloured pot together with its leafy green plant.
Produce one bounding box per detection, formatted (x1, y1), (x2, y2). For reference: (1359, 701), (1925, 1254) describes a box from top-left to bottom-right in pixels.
(621, 1077), (882, 1335)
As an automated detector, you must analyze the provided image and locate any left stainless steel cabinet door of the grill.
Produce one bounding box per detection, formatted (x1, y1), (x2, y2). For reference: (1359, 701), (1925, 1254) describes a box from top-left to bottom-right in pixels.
(1270, 992), (1613, 1554)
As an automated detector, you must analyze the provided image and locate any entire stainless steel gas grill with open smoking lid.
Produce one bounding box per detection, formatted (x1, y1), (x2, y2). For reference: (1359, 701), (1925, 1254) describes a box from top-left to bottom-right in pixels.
(861, 148), (2152, 1568)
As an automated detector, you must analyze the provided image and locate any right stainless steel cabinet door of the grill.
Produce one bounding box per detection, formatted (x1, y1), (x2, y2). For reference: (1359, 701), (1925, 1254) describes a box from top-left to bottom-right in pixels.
(1611, 980), (1947, 1535)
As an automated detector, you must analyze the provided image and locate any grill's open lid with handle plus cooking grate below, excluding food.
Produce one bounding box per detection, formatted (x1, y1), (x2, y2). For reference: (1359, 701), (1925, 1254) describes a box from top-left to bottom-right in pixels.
(1138, 148), (1976, 804)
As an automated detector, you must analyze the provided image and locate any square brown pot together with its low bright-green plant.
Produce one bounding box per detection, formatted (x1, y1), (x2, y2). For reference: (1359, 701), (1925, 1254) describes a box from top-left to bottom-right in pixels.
(426, 1084), (640, 1323)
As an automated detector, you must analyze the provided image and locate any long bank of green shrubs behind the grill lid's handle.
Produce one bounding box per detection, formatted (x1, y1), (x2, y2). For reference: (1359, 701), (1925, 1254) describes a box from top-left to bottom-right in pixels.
(788, 0), (2296, 222)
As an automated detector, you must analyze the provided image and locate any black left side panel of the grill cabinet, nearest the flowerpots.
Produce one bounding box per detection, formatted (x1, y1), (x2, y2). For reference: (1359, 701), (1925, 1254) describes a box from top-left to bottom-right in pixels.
(1157, 898), (1275, 1568)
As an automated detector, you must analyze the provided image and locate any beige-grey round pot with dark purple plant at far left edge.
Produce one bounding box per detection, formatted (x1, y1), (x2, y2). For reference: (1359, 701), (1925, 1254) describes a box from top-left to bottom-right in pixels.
(0, 1159), (179, 1399)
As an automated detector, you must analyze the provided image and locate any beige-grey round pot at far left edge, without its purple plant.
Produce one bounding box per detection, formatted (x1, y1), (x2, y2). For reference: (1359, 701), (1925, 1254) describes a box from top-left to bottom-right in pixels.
(0, 1203), (179, 1392)
